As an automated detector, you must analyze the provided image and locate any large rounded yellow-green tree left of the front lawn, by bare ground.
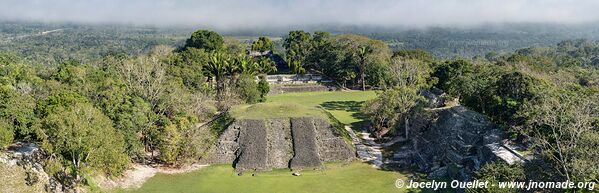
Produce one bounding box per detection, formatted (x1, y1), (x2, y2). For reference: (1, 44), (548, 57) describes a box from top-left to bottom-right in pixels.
(44, 103), (129, 181)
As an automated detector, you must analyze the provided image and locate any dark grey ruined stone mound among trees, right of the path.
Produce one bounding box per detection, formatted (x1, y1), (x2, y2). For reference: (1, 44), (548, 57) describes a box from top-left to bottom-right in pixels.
(392, 106), (525, 180)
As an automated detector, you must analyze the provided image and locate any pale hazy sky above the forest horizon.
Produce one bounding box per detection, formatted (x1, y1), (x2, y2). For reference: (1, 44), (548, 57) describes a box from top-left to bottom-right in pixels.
(0, 0), (599, 29)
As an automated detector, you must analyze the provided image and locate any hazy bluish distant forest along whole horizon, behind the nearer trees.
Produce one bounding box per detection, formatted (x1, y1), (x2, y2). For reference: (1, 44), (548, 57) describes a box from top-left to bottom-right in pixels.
(0, 22), (599, 64)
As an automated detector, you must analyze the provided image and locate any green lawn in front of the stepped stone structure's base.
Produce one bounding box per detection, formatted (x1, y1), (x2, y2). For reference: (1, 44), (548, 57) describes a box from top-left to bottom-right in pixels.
(117, 162), (406, 193)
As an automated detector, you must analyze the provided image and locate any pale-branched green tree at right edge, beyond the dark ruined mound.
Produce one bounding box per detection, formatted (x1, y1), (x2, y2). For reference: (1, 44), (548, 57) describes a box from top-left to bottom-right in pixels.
(521, 91), (599, 181)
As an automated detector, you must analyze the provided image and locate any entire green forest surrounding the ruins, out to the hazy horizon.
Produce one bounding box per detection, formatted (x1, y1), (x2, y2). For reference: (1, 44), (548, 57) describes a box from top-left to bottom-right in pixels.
(0, 21), (599, 192)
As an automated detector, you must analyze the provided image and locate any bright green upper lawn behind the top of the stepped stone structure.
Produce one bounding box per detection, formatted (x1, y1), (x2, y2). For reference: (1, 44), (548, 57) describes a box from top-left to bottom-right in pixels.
(267, 91), (376, 127)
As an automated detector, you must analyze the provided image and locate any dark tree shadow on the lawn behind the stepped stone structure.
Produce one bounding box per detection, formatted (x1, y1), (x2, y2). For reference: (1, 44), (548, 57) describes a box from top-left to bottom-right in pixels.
(320, 101), (368, 131)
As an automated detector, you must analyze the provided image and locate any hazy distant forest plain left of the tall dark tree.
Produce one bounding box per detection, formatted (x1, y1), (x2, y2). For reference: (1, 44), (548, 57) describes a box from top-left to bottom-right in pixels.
(0, 22), (188, 65)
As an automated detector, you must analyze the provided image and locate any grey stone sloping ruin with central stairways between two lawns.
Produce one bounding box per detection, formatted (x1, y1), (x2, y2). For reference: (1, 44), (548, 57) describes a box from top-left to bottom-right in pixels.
(204, 117), (355, 172)
